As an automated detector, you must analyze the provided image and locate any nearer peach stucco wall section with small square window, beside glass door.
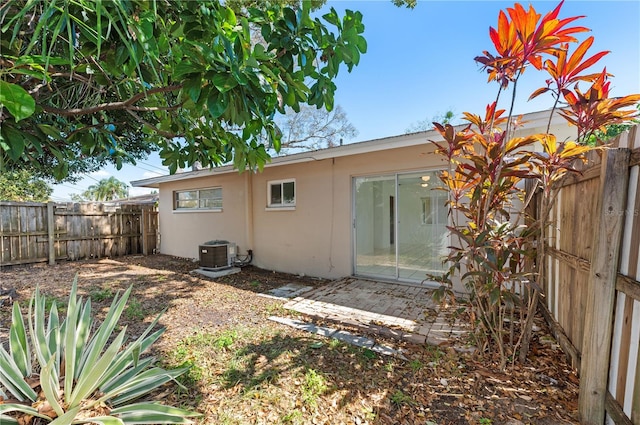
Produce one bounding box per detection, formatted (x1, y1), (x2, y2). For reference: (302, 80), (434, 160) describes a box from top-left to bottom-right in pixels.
(245, 143), (445, 278)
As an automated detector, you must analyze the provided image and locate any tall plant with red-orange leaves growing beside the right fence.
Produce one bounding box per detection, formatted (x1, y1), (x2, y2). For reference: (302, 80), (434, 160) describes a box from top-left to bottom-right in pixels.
(434, 2), (640, 368)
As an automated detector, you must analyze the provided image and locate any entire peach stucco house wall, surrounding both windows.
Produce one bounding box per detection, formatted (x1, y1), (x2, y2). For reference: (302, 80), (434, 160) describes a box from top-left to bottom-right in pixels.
(149, 112), (575, 286)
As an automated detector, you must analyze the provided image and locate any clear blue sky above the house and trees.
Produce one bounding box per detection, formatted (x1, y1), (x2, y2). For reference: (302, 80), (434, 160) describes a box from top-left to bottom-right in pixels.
(52, 0), (640, 201)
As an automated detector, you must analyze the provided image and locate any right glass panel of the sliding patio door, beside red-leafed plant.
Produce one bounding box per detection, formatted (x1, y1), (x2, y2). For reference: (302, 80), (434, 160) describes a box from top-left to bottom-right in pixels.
(396, 171), (448, 281)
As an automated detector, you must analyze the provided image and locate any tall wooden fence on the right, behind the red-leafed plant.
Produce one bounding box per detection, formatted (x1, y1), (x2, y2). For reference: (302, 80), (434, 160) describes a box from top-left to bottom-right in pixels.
(542, 126), (640, 425)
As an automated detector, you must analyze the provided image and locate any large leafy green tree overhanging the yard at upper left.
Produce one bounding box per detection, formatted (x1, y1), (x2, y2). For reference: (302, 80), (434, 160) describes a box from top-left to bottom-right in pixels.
(0, 0), (367, 180)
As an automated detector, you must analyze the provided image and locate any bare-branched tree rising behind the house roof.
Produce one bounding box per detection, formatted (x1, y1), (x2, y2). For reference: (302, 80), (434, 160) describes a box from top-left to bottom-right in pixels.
(276, 105), (358, 150)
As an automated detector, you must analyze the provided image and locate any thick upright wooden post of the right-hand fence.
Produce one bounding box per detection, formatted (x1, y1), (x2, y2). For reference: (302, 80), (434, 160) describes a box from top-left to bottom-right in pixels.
(578, 148), (631, 425)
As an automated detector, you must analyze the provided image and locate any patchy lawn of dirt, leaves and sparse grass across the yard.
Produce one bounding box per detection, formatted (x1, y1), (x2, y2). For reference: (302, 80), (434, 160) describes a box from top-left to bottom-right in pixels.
(0, 255), (578, 425)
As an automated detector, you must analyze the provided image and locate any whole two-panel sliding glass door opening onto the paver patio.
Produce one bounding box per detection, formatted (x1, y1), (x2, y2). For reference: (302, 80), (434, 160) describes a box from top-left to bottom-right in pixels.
(353, 171), (448, 282)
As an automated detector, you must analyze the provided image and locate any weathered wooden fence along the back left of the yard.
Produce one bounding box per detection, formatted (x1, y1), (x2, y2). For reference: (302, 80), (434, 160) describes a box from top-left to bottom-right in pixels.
(0, 202), (158, 266)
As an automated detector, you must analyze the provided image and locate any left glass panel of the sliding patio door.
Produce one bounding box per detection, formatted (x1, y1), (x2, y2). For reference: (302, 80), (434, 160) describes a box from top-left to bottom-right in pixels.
(353, 176), (397, 279)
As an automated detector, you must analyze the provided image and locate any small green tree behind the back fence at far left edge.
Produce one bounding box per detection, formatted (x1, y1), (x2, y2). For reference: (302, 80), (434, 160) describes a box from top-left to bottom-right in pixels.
(0, 170), (53, 202)
